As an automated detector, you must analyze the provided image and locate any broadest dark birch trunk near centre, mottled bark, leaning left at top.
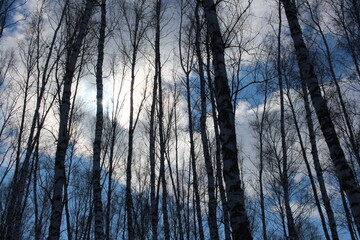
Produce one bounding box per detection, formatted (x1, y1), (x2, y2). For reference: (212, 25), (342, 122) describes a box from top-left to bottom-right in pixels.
(203, 0), (252, 240)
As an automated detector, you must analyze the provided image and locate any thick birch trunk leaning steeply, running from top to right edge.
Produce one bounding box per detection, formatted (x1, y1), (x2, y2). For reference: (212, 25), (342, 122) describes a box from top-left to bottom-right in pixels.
(281, 0), (360, 231)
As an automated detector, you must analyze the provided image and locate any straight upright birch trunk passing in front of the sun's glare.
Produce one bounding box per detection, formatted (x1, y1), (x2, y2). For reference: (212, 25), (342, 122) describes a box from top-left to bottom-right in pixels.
(93, 0), (106, 240)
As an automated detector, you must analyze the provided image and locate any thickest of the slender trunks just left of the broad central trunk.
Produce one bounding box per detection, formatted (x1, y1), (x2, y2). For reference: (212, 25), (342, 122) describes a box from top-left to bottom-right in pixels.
(195, 2), (219, 240)
